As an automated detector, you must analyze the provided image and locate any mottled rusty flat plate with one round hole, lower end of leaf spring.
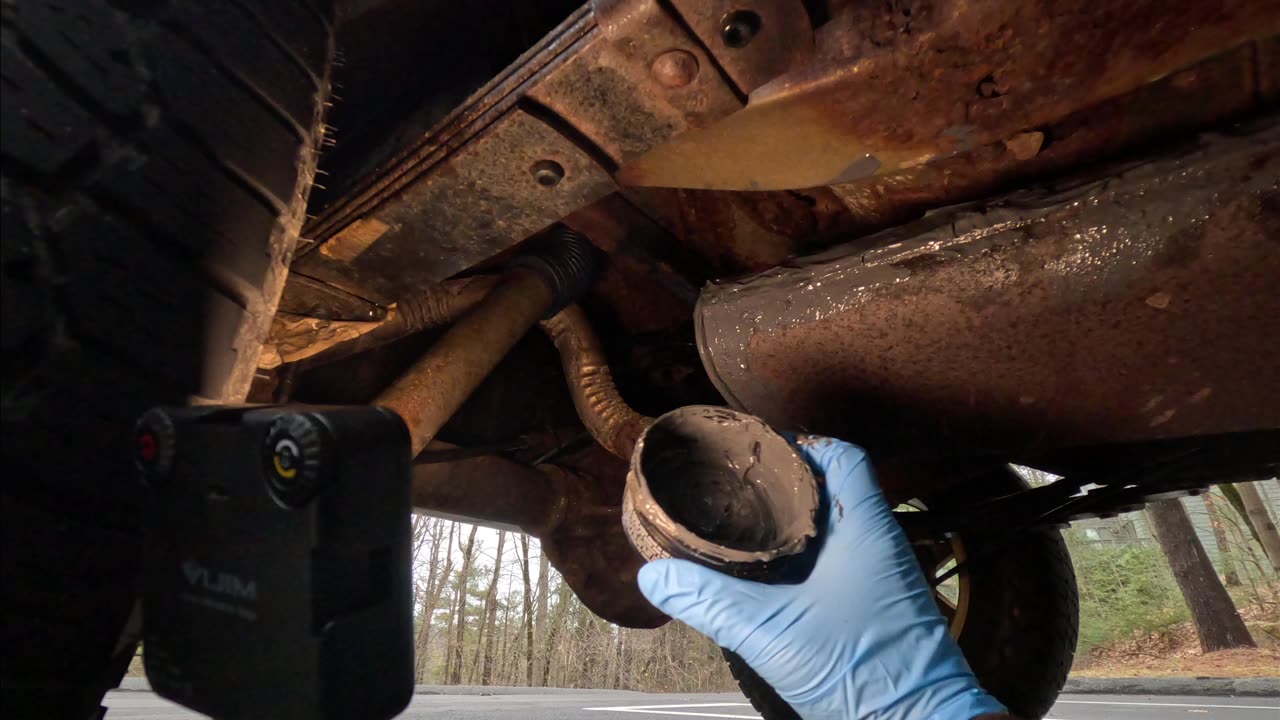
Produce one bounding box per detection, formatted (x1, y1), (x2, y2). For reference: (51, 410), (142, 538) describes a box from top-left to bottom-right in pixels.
(296, 108), (614, 302)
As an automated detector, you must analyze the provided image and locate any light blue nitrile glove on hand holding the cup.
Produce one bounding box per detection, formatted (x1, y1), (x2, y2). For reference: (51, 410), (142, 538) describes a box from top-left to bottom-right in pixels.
(640, 437), (1006, 720)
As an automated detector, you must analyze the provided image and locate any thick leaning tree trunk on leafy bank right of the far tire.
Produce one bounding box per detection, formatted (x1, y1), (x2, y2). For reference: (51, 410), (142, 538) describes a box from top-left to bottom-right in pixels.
(1147, 498), (1257, 652)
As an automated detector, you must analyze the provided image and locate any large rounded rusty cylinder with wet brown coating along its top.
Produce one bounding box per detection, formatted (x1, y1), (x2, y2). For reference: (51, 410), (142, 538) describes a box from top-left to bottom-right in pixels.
(696, 118), (1280, 456)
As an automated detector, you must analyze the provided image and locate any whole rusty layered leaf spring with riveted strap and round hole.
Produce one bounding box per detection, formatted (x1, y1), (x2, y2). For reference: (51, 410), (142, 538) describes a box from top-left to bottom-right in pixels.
(294, 0), (742, 304)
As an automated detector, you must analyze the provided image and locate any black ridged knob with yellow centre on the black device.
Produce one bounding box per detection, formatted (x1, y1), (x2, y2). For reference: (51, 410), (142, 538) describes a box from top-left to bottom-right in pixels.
(262, 413), (332, 507)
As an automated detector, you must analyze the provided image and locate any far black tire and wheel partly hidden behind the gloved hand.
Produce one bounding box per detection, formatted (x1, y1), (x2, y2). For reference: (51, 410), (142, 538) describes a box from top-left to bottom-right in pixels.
(722, 466), (1079, 720)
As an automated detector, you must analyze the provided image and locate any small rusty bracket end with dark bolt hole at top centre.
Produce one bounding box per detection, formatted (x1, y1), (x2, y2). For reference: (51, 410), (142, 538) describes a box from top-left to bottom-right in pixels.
(672, 0), (813, 95)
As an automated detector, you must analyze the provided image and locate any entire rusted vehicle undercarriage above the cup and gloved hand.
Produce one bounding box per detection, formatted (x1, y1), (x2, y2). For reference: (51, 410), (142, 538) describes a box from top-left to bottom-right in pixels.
(256, 0), (1280, 625)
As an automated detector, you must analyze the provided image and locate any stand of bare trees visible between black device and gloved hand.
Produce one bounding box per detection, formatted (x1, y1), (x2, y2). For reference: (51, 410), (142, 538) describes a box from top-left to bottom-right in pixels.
(399, 519), (732, 692)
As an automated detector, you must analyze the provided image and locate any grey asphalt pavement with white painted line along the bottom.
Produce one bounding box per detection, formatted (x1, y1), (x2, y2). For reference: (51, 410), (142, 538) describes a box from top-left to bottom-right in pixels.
(105, 688), (1280, 720)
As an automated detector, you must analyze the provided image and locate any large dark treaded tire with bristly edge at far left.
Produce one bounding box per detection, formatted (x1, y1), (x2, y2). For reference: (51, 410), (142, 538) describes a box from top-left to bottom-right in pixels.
(0, 0), (334, 719)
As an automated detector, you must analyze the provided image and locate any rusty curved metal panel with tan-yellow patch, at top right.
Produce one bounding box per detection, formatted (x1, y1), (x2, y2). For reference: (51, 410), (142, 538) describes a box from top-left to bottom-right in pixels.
(617, 0), (1280, 190)
